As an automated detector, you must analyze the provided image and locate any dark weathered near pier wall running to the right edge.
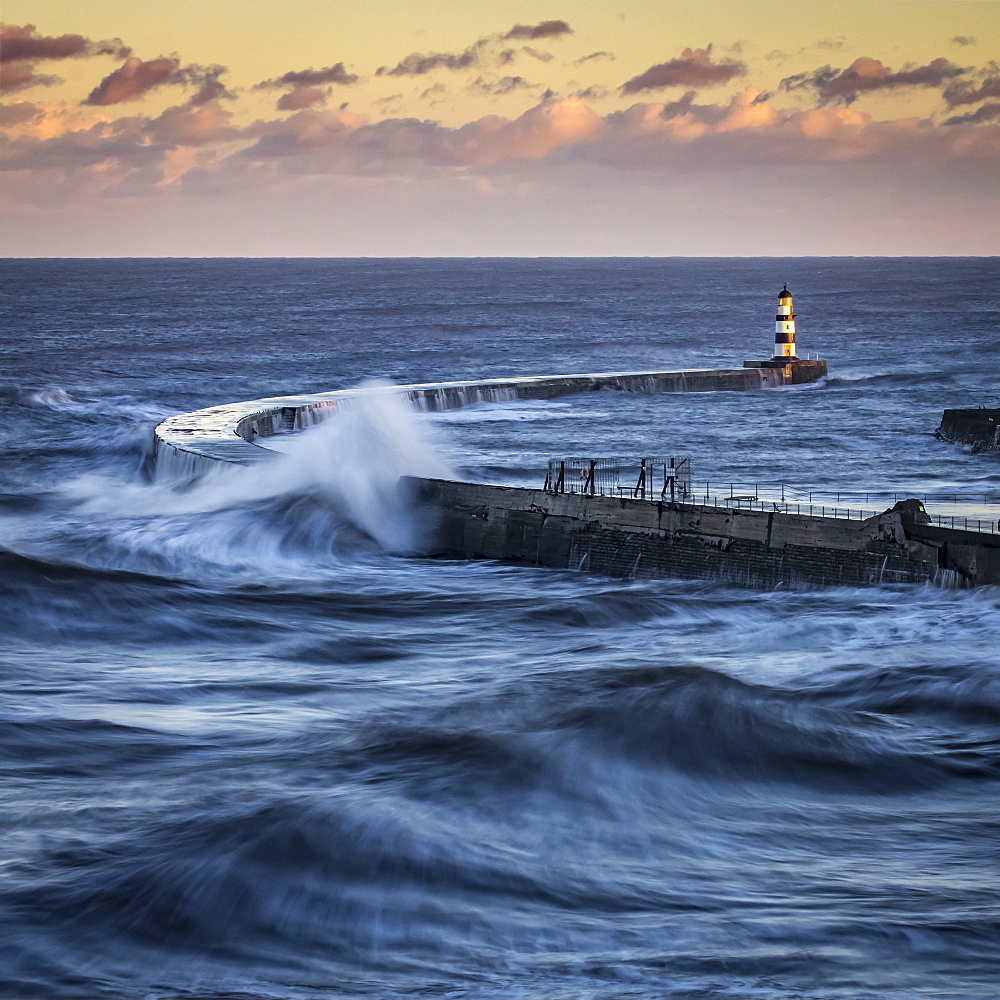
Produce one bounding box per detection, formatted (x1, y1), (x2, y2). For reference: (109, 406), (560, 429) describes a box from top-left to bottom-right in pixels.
(414, 480), (1000, 588)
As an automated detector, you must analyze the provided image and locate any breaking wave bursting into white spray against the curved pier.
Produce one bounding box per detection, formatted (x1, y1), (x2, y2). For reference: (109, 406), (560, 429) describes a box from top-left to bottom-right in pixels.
(0, 383), (452, 581)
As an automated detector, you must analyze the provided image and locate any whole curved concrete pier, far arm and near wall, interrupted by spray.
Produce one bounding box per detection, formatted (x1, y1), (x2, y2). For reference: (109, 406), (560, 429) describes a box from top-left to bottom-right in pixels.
(155, 361), (1000, 588)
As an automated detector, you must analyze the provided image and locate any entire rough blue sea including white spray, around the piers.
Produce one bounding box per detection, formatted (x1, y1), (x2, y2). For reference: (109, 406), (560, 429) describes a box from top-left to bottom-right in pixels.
(0, 259), (1000, 1000)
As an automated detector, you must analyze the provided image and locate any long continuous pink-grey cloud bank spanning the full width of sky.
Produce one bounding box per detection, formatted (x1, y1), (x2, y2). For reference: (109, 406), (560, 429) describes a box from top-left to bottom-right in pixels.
(0, 88), (1000, 228)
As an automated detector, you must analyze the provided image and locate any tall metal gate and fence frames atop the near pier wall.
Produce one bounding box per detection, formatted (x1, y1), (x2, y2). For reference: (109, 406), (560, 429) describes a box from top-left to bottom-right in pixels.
(545, 455), (691, 500)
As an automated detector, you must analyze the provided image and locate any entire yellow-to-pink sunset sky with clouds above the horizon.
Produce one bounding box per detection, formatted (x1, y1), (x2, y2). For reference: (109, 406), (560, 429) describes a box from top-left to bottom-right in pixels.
(0, 0), (1000, 257)
